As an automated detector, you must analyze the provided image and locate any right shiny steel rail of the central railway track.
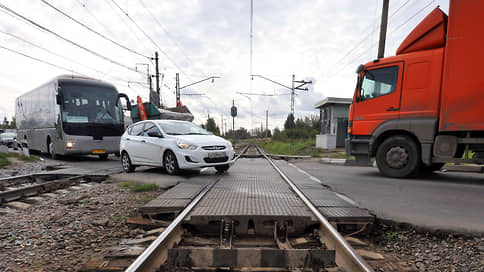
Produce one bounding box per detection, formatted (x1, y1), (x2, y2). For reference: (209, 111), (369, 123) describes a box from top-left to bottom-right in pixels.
(255, 145), (373, 272)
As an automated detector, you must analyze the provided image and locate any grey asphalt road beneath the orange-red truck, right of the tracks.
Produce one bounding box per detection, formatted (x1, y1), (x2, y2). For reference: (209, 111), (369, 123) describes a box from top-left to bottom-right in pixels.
(292, 161), (484, 233)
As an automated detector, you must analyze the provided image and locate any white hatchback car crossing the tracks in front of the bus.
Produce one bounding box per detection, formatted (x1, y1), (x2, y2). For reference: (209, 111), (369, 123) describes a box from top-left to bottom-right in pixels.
(119, 120), (235, 174)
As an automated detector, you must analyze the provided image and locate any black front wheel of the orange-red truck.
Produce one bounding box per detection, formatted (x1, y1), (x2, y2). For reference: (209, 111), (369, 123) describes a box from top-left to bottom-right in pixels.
(376, 136), (421, 178)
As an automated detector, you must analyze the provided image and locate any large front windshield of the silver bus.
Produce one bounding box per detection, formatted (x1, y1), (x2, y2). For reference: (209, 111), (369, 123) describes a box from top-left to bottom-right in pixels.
(61, 84), (123, 125)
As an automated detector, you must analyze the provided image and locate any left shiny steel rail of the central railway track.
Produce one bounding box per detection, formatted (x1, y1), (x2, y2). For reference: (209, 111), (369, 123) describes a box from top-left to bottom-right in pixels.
(125, 146), (249, 272)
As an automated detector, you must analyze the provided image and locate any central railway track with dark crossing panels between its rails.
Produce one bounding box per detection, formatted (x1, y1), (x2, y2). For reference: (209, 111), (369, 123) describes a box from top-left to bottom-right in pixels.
(117, 145), (373, 272)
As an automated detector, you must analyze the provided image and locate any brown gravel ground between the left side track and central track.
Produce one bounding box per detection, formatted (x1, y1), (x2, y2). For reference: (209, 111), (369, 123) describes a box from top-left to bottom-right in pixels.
(0, 181), (160, 271)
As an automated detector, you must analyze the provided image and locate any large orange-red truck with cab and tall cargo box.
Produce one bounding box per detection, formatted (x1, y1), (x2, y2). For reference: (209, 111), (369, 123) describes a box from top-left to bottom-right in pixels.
(346, 0), (484, 177)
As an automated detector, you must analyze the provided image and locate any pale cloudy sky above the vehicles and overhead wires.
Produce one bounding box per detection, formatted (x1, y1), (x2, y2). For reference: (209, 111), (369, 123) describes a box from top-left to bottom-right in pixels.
(0, 0), (448, 129)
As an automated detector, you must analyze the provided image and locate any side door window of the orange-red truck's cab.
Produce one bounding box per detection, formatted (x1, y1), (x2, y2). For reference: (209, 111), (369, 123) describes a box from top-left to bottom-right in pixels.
(360, 66), (398, 101)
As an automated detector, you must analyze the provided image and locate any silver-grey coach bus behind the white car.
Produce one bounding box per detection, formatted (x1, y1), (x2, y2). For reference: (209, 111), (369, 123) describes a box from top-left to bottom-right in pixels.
(15, 75), (130, 159)
